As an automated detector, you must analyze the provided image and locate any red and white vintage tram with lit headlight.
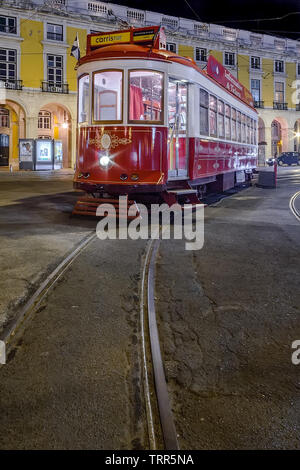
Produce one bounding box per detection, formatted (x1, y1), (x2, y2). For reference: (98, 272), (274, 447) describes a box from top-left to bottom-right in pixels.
(74, 27), (258, 203)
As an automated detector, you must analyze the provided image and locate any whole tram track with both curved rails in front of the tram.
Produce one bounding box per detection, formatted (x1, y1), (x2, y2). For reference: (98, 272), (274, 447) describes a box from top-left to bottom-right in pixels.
(0, 226), (179, 450)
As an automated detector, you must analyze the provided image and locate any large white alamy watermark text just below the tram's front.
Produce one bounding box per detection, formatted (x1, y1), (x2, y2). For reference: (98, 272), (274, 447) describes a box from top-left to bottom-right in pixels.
(96, 196), (204, 250)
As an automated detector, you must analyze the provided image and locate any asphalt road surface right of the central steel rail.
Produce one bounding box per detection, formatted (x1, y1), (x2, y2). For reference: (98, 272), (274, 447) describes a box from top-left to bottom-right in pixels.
(157, 168), (300, 449)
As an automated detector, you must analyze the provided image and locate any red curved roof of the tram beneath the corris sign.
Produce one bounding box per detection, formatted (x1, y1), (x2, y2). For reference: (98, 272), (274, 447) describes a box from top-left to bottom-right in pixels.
(79, 30), (257, 113)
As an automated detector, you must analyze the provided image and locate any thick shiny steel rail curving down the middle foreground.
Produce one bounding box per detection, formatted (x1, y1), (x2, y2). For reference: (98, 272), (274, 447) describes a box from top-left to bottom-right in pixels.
(147, 240), (179, 450)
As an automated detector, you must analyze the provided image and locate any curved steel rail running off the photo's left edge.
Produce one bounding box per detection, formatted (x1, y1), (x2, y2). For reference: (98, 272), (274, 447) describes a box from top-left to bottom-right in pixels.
(0, 232), (97, 350)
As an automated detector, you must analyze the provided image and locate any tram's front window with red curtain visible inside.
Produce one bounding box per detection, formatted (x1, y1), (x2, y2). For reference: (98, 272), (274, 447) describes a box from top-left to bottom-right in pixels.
(129, 70), (163, 123)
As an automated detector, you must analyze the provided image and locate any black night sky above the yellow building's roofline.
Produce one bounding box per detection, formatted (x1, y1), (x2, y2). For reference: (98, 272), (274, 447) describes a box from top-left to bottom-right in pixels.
(113, 0), (300, 39)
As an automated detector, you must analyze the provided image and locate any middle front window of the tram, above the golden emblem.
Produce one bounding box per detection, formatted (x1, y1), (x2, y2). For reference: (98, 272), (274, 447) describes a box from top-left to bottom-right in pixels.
(93, 70), (123, 122)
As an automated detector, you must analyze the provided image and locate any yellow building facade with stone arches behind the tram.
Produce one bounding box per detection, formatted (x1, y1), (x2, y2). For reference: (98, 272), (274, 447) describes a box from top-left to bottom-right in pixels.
(0, 0), (300, 169)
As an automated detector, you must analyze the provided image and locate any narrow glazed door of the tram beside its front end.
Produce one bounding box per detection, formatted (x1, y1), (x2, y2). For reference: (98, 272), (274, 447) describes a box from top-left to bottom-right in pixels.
(168, 79), (188, 179)
